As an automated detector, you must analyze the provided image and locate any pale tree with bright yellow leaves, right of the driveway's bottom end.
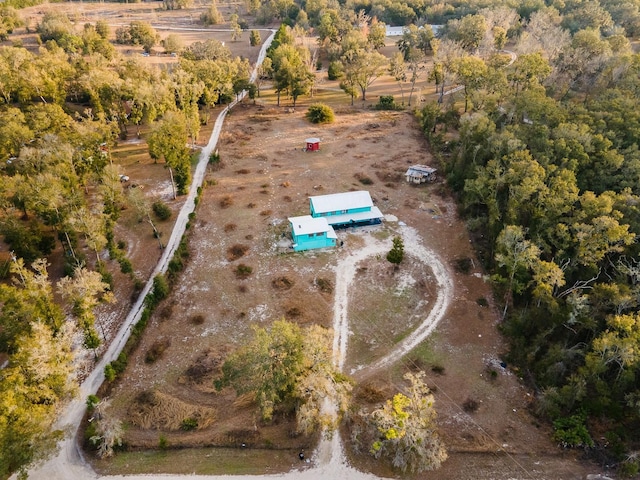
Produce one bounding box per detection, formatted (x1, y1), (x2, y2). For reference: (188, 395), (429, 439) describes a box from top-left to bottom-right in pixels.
(369, 372), (447, 472)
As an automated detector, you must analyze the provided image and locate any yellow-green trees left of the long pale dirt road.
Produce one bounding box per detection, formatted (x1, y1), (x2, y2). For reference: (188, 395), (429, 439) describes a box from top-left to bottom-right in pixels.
(0, 10), (255, 478)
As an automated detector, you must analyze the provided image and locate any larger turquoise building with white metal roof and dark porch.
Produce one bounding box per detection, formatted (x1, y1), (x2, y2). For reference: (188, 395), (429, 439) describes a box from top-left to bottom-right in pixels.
(309, 190), (384, 228)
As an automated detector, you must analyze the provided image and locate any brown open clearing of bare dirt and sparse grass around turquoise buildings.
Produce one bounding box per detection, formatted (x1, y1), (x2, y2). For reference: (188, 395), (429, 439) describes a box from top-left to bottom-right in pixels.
(95, 102), (600, 479)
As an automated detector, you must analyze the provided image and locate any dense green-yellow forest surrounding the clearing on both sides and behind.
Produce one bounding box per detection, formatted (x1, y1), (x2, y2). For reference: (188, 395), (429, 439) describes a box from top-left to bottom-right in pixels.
(0, 0), (640, 477)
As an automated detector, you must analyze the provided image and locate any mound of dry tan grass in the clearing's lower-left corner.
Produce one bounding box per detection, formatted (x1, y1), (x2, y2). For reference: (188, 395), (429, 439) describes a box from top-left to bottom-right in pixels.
(128, 390), (216, 431)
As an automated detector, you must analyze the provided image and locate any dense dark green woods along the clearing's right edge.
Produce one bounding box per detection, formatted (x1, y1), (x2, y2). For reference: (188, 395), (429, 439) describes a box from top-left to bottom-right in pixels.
(418, 1), (640, 474)
